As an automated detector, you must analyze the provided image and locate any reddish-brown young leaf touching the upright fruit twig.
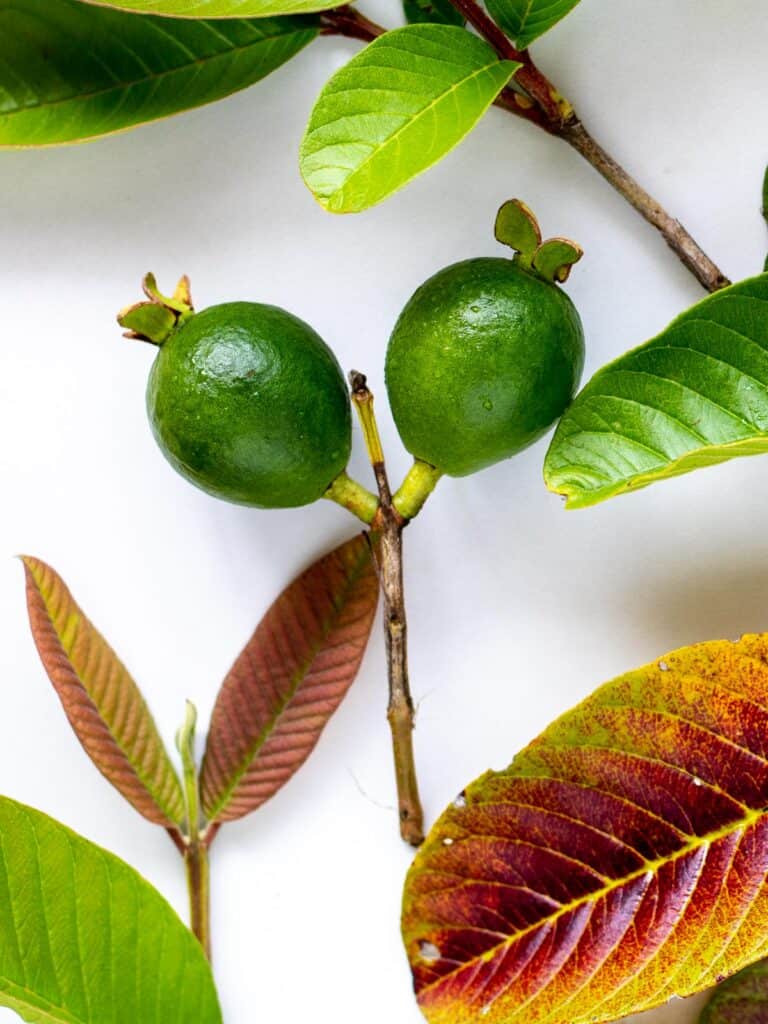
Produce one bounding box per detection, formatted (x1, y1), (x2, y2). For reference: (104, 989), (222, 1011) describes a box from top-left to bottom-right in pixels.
(201, 536), (379, 821)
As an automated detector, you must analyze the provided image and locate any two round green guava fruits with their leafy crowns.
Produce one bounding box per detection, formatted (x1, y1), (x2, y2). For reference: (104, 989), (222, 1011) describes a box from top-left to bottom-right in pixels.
(119, 200), (584, 508)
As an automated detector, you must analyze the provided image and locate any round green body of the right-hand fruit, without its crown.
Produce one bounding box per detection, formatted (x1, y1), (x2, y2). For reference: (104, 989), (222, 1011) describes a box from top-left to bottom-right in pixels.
(386, 257), (584, 476)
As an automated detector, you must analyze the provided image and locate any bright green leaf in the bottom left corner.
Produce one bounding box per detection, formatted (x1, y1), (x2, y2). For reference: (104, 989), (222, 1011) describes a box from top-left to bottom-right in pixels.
(0, 798), (221, 1024)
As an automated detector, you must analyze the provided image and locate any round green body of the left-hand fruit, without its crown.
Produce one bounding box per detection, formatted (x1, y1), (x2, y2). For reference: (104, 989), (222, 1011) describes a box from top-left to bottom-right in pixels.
(146, 302), (351, 508)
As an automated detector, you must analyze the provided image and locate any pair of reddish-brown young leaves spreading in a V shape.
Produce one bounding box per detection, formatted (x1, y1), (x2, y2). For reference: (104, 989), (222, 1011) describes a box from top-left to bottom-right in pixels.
(24, 535), (379, 835)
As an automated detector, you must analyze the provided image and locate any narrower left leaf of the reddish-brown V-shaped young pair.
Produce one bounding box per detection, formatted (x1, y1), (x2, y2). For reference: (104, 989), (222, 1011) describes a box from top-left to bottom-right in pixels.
(23, 557), (184, 827)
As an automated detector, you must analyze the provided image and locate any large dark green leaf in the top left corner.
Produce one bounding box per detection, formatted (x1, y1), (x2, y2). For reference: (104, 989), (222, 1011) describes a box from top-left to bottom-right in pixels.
(0, 0), (318, 146)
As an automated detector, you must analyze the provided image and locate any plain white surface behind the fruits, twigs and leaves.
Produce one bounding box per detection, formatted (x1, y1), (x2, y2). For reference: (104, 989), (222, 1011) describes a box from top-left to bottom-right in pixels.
(0, 0), (768, 1024)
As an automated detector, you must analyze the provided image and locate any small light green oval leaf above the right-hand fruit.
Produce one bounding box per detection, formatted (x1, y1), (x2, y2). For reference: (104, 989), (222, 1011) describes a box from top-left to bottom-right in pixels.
(300, 25), (520, 213)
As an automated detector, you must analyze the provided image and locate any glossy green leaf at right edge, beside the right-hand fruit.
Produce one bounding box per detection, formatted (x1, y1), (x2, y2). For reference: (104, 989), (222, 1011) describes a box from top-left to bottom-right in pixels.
(544, 274), (768, 508)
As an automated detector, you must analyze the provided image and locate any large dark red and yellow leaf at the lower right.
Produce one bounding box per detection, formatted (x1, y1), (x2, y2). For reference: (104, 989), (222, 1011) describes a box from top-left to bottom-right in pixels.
(402, 635), (768, 1024)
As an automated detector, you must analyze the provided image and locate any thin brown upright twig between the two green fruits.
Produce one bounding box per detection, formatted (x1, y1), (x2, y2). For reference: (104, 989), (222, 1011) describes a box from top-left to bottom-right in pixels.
(349, 371), (424, 846)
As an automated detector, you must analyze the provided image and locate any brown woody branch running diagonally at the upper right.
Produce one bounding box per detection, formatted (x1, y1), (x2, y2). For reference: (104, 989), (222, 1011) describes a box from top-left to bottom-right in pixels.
(324, 0), (730, 292)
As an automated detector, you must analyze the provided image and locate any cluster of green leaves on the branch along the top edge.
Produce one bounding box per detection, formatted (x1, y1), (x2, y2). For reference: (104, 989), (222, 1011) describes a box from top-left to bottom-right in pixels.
(0, 0), (578, 207)
